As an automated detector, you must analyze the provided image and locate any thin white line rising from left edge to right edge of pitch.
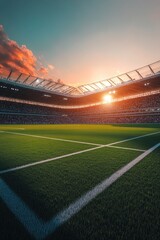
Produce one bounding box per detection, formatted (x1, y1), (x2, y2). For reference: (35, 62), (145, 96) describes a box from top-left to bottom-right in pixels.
(0, 132), (160, 175)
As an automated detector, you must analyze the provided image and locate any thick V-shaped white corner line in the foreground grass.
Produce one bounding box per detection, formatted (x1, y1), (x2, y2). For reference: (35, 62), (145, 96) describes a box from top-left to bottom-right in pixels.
(0, 143), (160, 240)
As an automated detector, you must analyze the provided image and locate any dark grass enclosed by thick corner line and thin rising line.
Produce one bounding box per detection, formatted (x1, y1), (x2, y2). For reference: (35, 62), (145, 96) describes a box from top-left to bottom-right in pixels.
(3, 149), (138, 219)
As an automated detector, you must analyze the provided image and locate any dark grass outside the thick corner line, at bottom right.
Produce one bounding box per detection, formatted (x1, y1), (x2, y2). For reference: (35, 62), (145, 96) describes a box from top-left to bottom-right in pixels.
(57, 150), (160, 240)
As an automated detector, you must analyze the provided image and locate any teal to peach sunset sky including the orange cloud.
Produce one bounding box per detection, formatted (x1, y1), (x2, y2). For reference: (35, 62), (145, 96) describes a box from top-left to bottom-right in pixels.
(0, 0), (160, 86)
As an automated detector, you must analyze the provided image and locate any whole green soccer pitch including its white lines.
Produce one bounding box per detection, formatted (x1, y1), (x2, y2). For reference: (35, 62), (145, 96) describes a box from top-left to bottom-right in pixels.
(0, 124), (160, 240)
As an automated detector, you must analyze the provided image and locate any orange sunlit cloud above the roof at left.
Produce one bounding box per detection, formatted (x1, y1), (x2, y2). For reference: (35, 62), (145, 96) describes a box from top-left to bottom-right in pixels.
(0, 25), (55, 79)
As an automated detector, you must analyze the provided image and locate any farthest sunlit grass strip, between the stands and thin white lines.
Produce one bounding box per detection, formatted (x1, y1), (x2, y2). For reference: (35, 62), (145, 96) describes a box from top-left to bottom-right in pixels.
(0, 124), (160, 144)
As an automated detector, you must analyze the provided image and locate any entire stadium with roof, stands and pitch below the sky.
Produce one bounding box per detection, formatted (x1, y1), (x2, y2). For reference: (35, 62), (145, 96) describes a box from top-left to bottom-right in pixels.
(0, 61), (160, 239)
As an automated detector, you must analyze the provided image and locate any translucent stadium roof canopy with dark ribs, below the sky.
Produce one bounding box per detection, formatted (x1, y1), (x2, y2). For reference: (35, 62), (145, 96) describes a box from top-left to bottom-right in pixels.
(0, 60), (160, 96)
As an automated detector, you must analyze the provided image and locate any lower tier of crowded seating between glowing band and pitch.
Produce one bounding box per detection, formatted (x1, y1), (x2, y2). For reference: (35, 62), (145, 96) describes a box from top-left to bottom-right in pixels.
(0, 94), (160, 124)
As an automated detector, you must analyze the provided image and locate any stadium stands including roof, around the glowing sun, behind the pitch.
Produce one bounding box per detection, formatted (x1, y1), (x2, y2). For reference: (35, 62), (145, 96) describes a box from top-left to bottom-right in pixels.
(0, 61), (160, 124)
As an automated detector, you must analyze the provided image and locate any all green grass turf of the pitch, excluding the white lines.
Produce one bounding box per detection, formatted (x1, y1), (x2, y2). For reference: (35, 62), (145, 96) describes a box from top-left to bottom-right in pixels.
(0, 125), (160, 240)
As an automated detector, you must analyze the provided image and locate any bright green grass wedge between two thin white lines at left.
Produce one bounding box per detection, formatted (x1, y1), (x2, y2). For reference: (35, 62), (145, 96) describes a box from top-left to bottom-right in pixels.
(0, 133), (92, 170)
